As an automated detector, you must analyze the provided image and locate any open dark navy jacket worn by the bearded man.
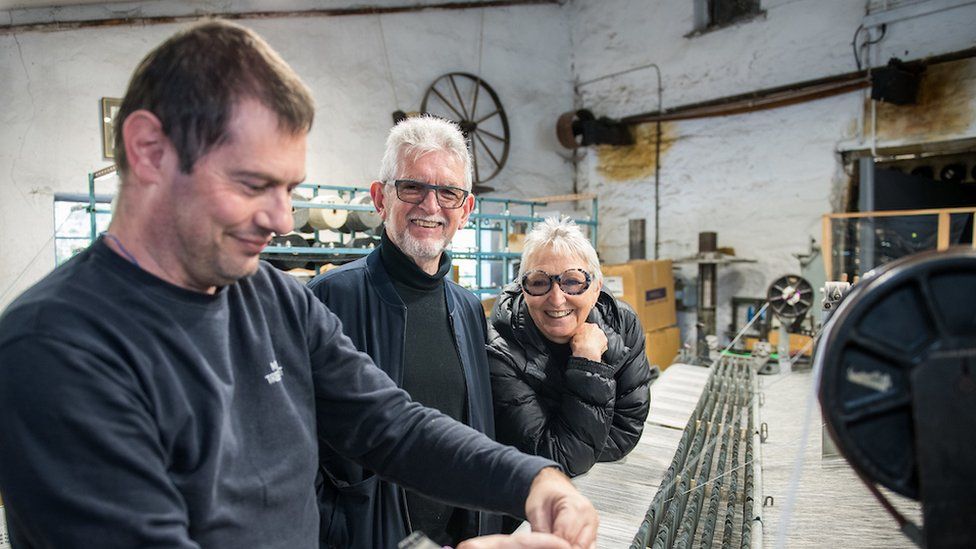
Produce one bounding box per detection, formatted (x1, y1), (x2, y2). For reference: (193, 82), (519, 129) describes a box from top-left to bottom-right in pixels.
(309, 249), (501, 549)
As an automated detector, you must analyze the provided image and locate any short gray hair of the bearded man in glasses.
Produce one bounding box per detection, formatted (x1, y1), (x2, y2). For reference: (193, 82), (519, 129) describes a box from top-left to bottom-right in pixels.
(379, 115), (471, 190)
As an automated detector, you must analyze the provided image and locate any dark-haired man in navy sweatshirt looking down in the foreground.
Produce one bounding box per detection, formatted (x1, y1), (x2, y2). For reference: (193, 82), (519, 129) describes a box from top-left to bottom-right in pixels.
(0, 21), (597, 549)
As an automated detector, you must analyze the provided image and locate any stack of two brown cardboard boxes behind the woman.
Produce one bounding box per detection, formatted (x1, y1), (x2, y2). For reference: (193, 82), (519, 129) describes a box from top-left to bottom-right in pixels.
(602, 259), (681, 370)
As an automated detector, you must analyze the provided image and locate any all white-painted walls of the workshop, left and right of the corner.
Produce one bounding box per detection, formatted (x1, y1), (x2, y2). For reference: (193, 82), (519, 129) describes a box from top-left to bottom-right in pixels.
(0, 0), (976, 335)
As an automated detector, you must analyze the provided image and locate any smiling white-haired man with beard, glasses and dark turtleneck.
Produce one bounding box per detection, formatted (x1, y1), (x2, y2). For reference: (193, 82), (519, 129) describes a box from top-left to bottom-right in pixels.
(309, 116), (500, 547)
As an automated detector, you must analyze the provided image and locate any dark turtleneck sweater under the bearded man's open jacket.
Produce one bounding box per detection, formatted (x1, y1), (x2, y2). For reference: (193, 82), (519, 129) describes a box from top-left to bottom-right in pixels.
(380, 231), (477, 545)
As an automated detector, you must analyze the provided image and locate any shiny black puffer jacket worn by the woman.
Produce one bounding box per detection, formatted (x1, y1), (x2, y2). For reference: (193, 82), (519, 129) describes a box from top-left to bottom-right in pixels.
(488, 284), (658, 476)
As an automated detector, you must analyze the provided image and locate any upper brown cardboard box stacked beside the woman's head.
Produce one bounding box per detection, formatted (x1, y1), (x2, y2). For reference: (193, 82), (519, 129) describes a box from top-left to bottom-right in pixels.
(601, 259), (678, 331)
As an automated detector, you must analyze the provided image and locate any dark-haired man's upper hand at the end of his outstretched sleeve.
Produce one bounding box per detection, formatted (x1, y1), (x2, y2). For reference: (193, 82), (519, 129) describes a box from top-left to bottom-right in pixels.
(525, 467), (600, 549)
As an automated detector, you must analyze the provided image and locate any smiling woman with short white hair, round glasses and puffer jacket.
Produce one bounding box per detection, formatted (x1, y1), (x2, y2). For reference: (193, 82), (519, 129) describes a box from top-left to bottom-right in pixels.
(488, 218), (657, 476)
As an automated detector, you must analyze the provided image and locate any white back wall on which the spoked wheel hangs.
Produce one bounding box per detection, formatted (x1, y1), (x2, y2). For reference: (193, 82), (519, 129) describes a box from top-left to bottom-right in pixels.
(0, 3), (573, 307)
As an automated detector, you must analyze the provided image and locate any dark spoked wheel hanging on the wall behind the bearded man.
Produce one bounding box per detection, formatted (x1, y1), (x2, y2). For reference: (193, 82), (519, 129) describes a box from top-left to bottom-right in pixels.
(420, 72), (510, 186)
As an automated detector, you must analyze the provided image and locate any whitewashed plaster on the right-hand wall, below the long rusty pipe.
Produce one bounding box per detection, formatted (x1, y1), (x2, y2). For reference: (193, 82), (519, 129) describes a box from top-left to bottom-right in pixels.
(580, 95), (858, 338)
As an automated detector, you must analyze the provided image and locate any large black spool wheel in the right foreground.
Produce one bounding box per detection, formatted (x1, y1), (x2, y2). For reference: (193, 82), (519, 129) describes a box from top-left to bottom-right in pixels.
(817, 250), (976, 499)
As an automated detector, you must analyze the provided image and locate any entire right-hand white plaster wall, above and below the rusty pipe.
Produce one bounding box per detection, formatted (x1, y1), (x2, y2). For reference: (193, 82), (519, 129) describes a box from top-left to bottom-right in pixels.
(570, 0), (976, 340)
